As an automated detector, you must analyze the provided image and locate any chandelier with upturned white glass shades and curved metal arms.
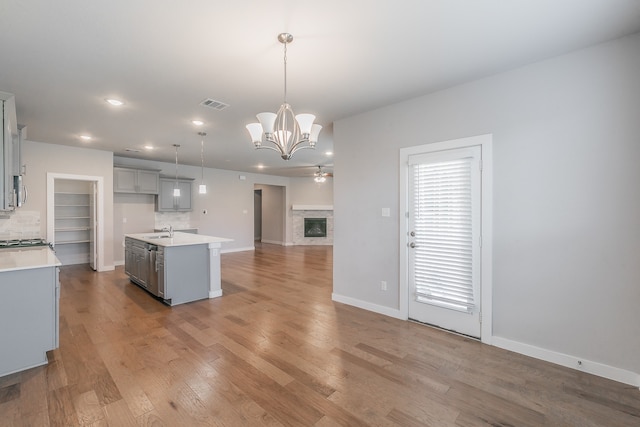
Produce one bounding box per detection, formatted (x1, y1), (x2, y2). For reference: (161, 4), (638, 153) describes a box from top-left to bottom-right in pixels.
(247, 33), (322, 160)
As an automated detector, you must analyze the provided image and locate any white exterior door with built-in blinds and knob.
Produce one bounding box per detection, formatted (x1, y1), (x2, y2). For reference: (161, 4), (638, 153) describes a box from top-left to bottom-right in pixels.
(408, 146), (481, 338)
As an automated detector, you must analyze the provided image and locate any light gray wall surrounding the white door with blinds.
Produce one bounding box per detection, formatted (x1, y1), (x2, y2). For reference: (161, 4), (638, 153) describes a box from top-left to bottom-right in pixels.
(334, 35), (640, 380)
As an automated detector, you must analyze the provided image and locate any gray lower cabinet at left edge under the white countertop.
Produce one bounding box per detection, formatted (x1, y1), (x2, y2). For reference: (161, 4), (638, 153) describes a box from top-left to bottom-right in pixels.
(0, 266), (60, 377)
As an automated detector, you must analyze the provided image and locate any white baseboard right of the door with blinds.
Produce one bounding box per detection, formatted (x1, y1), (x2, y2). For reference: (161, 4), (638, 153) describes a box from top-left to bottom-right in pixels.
(492, 336), (640, 387)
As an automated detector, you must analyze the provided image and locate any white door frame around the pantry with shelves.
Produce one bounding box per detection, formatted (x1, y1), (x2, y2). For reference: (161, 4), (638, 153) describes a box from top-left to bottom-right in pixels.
(47, 172), (106, 271)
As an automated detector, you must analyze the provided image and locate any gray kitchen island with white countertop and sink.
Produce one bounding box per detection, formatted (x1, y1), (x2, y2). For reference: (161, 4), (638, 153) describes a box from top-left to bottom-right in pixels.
(124, 232), (233, 305)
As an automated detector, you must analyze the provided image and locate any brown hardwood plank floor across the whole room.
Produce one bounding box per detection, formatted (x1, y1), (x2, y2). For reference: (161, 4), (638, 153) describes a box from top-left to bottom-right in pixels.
(0, 245), (640, 427)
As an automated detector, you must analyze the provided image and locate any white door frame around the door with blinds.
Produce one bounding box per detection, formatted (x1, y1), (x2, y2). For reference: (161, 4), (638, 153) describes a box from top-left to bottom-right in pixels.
(398, 134), (493, 344)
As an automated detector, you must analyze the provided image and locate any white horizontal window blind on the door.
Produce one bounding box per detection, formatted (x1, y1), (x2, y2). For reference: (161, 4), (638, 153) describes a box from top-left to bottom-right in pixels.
(413, 158), (475, 313)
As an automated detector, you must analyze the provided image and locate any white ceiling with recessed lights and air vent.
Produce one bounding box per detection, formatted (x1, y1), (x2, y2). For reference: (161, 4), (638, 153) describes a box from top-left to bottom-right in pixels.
(0, 0), (640, 176)
